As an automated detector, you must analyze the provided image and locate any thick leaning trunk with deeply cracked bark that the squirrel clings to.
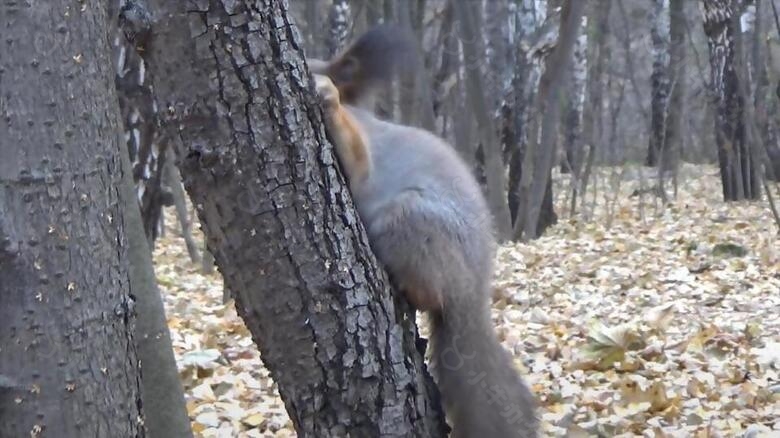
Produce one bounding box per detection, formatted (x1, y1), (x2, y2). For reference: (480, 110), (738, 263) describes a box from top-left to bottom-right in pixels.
(145, 0), (444, 437)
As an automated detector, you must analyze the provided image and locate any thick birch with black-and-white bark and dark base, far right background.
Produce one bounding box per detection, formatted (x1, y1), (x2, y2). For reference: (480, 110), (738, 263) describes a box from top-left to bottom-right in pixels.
(701, 0), (761, 201)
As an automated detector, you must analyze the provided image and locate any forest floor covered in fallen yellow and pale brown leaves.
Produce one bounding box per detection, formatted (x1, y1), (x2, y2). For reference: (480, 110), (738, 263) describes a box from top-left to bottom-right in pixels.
(155, 165), (780, 437)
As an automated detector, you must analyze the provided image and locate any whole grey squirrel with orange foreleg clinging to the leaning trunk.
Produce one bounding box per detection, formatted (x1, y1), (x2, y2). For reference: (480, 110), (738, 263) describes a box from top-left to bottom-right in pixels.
(307, 25), (538, 438)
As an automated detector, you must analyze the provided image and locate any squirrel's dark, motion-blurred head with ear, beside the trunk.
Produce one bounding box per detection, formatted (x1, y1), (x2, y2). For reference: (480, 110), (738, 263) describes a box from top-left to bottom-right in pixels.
(307, 25), (419, 106)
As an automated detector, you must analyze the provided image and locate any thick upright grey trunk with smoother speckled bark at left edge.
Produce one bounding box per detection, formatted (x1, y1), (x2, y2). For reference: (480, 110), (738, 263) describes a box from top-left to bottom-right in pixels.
(0, 1), (144, 438)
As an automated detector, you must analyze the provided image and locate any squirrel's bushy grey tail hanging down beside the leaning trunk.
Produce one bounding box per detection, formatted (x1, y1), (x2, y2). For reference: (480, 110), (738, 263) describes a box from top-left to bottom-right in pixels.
(430, 290), (538, 438)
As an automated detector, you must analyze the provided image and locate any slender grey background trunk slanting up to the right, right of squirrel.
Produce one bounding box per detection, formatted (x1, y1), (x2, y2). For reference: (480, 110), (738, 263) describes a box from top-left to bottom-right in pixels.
(514, 0), (585, 239)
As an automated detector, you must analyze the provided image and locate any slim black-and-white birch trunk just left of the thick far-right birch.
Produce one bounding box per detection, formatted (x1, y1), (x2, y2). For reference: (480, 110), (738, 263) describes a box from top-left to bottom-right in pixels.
(645, 0), (670, 166)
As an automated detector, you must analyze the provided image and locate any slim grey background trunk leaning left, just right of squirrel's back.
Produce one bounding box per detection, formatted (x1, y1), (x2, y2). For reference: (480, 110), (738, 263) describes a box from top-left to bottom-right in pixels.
(452, 0), (511, 239)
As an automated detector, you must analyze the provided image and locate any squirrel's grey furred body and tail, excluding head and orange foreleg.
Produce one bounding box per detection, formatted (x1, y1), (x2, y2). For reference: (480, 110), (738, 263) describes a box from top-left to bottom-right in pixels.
(346, 106), (538, 438)
